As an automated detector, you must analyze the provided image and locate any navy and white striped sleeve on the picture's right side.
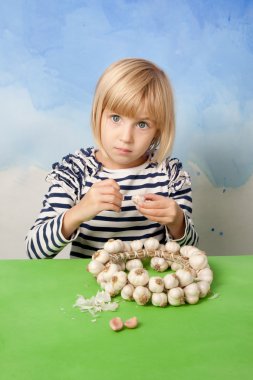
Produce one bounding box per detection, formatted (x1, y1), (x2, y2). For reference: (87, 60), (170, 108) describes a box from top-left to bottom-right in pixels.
(166, 158), (198, 246)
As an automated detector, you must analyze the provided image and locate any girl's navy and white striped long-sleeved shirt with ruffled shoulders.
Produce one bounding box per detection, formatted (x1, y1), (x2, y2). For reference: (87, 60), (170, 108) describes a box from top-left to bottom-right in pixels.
(26, 148), (198, 259)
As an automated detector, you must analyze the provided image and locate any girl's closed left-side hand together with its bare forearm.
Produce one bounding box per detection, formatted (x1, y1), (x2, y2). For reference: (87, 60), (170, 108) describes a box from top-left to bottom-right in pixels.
(62, 179), (123, 239)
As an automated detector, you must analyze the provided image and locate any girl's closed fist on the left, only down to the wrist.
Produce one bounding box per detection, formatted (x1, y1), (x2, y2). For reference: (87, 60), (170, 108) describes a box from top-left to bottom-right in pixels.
(76, 179), (123, 224)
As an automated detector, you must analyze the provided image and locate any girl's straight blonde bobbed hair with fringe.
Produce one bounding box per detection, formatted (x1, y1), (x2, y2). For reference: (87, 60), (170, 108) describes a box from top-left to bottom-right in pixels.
(91, 58), (175, 163)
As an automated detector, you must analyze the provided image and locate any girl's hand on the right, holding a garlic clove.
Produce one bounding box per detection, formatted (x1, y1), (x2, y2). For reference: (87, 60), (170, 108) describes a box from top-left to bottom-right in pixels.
(136, 193), (185, 239)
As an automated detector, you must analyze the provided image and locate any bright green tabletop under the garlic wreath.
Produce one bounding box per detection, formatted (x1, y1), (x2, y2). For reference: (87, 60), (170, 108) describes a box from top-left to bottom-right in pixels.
(0, 256), (253, 380)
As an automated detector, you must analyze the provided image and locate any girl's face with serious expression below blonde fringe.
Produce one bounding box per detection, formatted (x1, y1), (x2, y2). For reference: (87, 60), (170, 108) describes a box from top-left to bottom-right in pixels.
(97, 109), (157, 169)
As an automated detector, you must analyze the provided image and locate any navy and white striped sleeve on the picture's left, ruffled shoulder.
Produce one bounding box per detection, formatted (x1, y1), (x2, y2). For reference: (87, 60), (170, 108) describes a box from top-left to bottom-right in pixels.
(26, 156), (84, 259)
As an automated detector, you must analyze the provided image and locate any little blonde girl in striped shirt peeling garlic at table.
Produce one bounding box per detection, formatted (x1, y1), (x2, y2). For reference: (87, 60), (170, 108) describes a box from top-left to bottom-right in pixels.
(26, 59), (198, 259)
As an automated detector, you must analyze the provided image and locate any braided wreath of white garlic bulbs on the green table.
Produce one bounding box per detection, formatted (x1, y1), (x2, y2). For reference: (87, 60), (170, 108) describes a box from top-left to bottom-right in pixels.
(87, 238), (213, 307)
